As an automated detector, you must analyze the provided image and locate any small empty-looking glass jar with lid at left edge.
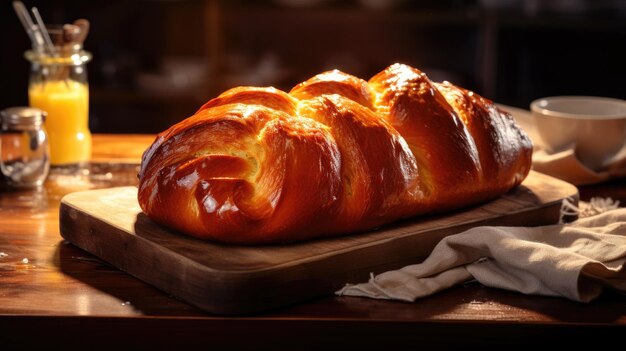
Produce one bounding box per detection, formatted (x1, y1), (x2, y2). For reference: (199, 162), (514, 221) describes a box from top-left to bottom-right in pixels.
(0, 107), (50, 188)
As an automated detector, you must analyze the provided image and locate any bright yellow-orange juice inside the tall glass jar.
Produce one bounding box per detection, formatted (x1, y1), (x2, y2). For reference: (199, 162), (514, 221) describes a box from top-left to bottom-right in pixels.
(28, 79), (91, 166)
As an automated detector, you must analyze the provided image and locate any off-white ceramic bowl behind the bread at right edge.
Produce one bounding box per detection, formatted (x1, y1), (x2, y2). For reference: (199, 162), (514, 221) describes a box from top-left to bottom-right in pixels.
(530, 96), (626, 170)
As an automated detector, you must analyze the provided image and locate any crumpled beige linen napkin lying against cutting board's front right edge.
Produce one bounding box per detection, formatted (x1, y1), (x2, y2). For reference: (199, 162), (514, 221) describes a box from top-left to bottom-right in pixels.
(336, 200), (626, 302)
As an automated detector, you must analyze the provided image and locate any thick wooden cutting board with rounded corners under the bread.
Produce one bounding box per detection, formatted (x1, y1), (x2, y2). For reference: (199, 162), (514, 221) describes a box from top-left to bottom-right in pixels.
(60, 172), (578, 314)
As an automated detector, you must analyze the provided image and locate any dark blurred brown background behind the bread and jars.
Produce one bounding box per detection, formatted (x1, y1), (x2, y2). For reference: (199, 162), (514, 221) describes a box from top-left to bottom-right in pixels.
(0, 0), (626, 133)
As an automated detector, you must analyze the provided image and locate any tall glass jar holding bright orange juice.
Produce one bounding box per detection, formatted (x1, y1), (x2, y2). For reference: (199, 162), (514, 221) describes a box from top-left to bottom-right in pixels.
(25, 36), (91, 167)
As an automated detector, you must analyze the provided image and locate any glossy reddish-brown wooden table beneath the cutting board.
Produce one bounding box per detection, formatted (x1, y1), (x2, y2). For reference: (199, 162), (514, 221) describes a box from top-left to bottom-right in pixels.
(0, 135), (626, 350)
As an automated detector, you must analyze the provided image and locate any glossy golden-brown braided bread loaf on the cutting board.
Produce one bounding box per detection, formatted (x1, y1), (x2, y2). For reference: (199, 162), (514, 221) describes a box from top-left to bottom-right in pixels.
(138, 64), (532, 244)
